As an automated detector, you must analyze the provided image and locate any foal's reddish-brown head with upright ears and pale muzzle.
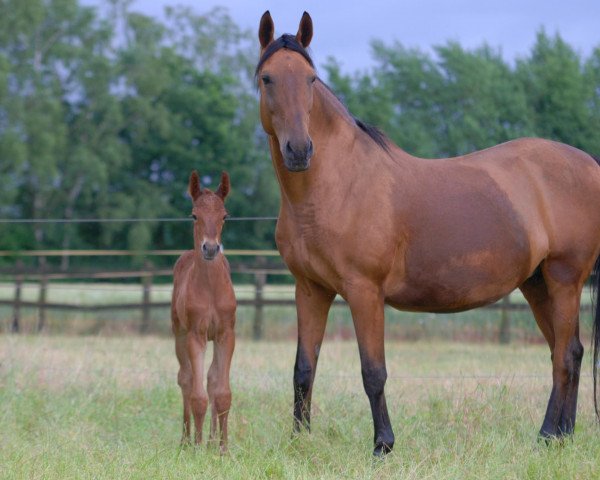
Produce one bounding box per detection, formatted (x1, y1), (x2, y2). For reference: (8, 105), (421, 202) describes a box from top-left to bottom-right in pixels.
(188, 170), (229, 260)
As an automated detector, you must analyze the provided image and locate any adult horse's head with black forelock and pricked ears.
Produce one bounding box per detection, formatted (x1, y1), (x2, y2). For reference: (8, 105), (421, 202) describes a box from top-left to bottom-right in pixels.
(256, 11), (317, 172)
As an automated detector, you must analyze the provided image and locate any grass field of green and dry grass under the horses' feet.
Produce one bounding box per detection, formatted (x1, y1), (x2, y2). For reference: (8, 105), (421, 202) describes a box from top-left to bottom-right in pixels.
(0, 335), (600, 479)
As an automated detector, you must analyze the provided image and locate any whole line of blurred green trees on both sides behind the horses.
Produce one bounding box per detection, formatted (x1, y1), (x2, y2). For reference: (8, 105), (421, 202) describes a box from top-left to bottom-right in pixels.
(0, 0), (600, 266)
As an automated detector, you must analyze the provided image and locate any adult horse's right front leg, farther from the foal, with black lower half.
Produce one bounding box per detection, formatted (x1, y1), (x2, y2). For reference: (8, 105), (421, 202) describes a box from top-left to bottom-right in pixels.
(347, 282), (394, 456)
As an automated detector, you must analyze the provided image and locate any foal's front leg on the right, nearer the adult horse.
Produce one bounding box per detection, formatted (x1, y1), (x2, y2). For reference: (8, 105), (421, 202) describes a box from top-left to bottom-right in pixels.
(211, 322), (235, 454)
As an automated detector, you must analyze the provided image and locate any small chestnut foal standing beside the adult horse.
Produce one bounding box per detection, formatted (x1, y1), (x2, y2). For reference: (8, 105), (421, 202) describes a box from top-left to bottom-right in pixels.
(171, 171), (236, 453)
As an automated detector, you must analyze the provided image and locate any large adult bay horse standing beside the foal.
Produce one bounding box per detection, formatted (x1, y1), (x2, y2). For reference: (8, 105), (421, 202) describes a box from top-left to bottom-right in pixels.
(256, 12), (600, 455)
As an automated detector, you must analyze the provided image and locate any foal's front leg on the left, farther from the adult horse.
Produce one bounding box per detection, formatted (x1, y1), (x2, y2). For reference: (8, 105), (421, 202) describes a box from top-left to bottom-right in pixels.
(187, 332), (208, 444)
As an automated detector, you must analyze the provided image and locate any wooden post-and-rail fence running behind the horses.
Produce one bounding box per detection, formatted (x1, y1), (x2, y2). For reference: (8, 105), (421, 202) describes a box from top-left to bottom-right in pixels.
(0, 250), (589, 343)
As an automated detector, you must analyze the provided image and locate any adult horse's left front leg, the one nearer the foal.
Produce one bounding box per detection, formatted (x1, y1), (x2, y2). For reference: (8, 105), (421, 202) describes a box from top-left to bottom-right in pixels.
(294, 279), (335, 432)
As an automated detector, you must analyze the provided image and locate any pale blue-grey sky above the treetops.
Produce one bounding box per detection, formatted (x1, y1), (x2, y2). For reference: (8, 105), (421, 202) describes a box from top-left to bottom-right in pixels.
(94, 0), (600, 71)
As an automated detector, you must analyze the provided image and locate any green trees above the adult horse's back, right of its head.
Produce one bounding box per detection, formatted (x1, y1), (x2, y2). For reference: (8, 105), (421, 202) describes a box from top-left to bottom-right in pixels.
(326, 31), (600, 157)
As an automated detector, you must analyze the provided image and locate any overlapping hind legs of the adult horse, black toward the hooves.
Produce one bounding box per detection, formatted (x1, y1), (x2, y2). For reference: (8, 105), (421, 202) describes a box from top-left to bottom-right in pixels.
(521, 261), (583, 438)
